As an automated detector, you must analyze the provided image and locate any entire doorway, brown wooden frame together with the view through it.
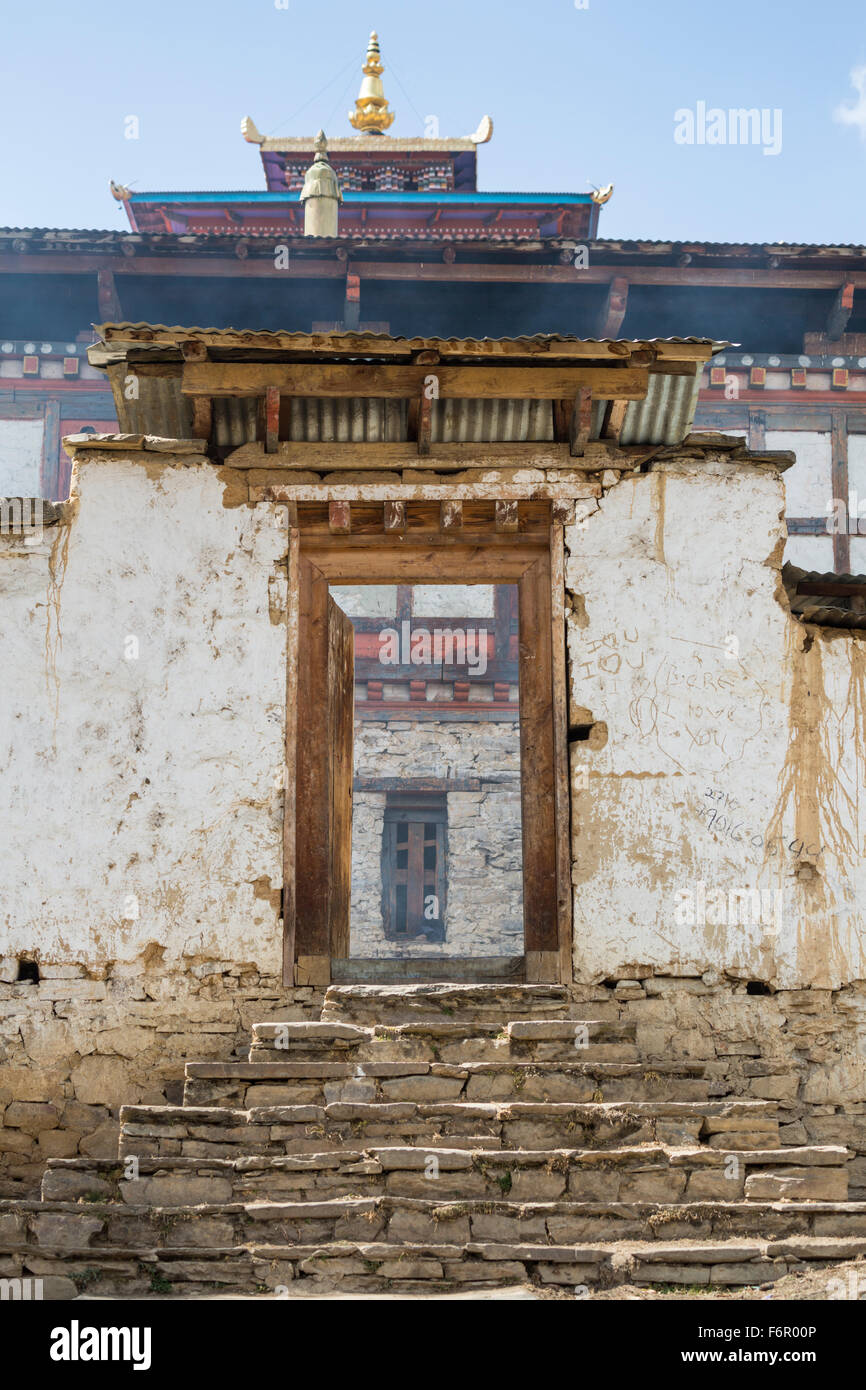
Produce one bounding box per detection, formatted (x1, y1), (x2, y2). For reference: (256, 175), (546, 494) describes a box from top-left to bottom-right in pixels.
(284, 502), (571, 984)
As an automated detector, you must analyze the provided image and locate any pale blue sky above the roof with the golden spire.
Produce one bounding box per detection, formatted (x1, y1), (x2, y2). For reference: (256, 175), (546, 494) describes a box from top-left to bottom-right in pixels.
(0, 0), (866, 242)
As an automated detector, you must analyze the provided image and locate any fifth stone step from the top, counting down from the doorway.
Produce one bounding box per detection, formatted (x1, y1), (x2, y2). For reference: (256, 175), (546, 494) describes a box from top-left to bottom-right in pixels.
(42, 1144), (848, 1207)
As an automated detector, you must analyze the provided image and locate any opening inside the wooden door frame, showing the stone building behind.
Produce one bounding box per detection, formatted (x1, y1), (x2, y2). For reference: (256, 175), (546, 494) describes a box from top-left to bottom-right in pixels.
(331, 584), (524, 979)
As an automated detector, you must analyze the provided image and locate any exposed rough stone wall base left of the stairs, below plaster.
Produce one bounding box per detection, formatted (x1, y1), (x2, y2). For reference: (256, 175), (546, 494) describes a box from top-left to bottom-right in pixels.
(0, 951), (324, 1197)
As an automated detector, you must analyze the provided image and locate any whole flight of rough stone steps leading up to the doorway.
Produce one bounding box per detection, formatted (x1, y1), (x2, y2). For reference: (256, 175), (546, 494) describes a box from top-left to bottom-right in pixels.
(0, 984), (866, 1298)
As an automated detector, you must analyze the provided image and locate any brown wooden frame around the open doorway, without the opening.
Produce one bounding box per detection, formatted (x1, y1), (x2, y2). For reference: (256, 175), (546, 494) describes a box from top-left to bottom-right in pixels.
(284, 523), (573, 986)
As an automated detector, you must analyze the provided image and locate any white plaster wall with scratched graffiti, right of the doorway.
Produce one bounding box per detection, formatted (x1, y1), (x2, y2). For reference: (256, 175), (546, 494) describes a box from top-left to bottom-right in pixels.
(566, 463), (866, 987)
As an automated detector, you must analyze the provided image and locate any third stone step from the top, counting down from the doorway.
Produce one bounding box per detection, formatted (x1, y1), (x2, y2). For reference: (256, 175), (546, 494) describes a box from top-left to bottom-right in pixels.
(183, 1061), (727, 1109)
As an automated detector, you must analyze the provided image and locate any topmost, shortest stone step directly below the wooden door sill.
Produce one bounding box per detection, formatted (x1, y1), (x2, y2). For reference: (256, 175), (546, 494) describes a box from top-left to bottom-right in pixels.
(321, 984), (571, 1023)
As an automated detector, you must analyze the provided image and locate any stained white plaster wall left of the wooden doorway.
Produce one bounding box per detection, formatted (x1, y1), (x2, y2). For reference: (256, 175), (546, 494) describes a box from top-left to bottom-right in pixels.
(0, 455), (286, 973)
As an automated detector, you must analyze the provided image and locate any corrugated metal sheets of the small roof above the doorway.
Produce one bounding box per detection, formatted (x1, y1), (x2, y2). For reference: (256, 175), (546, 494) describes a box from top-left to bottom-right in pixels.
(89, 324), (724, 446)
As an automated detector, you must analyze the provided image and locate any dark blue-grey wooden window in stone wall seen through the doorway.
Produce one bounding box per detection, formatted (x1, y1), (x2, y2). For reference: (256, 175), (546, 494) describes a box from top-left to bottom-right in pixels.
(382, 792), (448, 941)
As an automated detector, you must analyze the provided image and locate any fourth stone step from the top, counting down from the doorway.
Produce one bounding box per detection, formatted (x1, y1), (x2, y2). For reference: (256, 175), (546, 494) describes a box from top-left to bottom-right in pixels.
(120, 1095), (780, 1162)
